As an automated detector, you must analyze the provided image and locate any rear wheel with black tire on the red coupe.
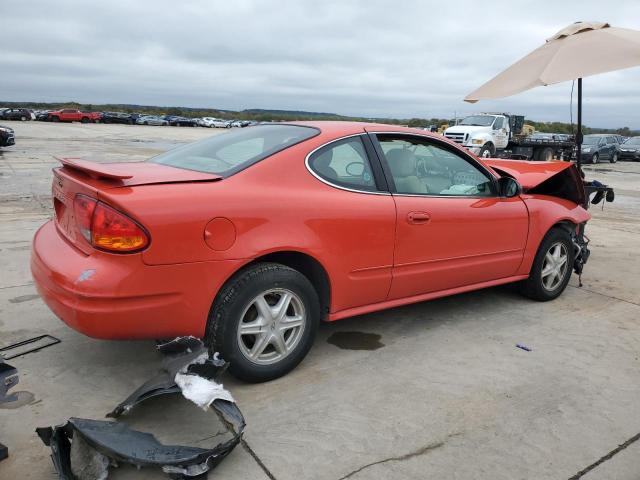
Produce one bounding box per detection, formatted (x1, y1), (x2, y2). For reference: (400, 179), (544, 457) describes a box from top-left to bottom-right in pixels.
(205, 263), (320, 383)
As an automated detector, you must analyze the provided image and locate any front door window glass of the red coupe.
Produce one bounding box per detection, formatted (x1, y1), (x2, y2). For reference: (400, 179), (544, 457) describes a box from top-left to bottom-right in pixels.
(378, 135), (494, 197)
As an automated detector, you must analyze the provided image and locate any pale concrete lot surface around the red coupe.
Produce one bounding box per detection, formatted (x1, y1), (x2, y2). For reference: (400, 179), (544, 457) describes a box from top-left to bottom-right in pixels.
(0, 122), (640, 480)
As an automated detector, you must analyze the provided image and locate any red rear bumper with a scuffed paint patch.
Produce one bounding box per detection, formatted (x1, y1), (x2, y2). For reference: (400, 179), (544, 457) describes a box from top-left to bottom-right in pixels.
(31, 222), (244, 339)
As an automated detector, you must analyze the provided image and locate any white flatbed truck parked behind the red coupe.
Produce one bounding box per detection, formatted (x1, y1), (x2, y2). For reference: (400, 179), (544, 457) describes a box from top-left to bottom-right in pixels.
(444, 113), (575, 161)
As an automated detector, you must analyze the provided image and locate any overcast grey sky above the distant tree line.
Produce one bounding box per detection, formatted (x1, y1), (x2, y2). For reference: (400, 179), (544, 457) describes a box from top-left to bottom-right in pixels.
(0, 0), (640, 128)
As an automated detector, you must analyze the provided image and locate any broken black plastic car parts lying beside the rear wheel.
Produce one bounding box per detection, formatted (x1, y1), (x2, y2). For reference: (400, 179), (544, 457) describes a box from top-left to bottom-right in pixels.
(36, 337), (245, 480)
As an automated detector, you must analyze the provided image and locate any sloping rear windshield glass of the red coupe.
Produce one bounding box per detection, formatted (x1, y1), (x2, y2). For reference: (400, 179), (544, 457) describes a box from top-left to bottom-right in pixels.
(149, 124), (320, 177)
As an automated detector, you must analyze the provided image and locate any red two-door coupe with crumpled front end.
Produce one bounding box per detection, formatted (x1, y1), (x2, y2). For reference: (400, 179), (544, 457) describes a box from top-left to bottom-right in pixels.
(31, 122), (590, 381)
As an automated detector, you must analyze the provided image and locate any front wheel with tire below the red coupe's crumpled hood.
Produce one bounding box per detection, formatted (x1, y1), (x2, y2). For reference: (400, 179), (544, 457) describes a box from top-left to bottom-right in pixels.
(520, 228), (574, 302)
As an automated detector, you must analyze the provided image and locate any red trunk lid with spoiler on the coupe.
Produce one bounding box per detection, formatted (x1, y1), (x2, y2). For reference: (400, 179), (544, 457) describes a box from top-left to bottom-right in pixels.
(57, 158), (222, 187)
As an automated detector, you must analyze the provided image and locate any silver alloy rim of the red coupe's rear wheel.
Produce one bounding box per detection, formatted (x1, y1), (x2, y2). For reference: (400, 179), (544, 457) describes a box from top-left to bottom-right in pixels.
(237, 288), (307, 365)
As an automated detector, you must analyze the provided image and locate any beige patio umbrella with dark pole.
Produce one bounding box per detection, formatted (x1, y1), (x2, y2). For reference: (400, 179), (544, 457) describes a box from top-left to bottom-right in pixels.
(464, 22), (640, 168)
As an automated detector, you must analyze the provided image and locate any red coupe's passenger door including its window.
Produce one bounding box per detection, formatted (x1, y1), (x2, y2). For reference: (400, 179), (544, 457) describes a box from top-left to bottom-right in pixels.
(374, 133), (529, 300)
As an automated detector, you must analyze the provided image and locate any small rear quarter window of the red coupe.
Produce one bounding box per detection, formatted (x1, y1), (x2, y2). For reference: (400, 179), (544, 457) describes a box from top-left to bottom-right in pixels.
(309, 137), (377, 192)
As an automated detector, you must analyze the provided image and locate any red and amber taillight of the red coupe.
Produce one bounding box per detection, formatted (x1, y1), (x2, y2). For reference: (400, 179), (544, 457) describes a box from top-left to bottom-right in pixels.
(74, 195), (149, 253)
